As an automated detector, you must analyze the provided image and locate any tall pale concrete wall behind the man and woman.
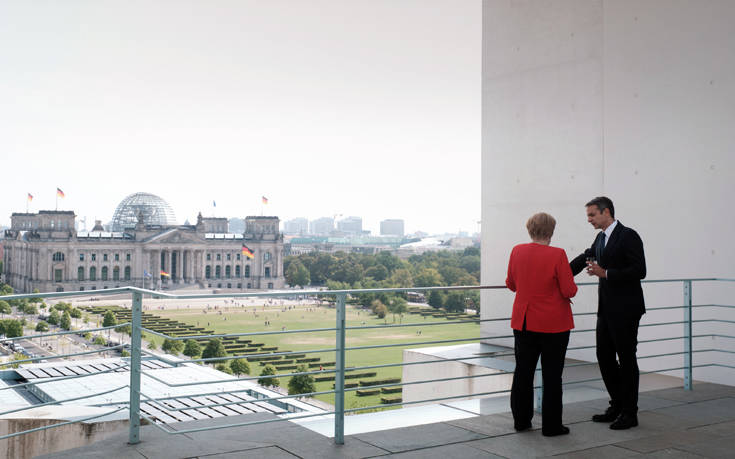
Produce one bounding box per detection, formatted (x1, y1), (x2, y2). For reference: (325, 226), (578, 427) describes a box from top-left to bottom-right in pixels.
(482, 0), (735, 379)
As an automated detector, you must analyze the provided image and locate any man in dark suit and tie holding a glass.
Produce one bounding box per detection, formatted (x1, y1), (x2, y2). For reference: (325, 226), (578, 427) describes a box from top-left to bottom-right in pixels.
(570, 196), (646, 430)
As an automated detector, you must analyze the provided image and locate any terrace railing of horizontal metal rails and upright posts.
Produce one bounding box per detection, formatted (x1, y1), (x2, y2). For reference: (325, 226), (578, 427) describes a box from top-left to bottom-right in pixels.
(0, 278), (735, 444)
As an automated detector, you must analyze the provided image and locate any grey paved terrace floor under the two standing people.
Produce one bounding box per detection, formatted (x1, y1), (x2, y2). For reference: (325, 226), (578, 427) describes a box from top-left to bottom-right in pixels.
(43, 383), (735, 459)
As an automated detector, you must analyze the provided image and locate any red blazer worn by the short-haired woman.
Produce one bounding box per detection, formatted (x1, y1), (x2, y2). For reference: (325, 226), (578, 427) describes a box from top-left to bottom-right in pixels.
(505, 243), (577, 333)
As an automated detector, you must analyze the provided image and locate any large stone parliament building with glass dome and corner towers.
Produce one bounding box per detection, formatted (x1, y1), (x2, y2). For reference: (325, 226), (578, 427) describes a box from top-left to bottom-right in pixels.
(3, 193), (285, 292)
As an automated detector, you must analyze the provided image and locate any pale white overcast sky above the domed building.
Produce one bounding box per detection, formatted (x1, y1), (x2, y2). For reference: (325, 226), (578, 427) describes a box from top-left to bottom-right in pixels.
(0, 0), (481, 233)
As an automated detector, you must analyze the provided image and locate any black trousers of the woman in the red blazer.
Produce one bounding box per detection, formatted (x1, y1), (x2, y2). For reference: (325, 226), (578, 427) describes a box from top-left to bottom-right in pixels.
(510, 330), (569, 430)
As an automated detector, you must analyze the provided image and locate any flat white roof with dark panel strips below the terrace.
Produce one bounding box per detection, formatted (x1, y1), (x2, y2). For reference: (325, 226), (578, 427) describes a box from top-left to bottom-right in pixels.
(5, 356), (324, 424)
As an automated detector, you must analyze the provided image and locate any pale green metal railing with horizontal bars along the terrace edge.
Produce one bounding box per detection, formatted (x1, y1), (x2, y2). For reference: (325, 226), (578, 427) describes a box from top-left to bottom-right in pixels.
(0, 278), (735, 444)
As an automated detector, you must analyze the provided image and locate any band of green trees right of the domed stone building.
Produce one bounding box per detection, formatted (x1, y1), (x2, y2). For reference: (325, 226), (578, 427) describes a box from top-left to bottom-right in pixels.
(284, 247), (480, 311)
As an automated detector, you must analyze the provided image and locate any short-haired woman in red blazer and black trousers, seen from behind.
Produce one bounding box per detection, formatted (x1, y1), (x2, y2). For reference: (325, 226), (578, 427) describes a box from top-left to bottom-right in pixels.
(505, 213), (577, 436)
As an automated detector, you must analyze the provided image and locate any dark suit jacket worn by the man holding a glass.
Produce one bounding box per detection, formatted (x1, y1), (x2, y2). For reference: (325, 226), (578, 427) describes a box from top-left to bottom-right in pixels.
(569, 221), (646, 320)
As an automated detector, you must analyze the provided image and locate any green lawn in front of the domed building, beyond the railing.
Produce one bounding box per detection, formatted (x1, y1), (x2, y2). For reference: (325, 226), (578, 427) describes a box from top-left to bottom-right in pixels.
(147, 305), (480, 409)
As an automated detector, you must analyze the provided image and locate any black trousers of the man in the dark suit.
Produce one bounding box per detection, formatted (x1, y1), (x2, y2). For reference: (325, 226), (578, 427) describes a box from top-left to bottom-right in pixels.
(596, 314), (641, 415)
